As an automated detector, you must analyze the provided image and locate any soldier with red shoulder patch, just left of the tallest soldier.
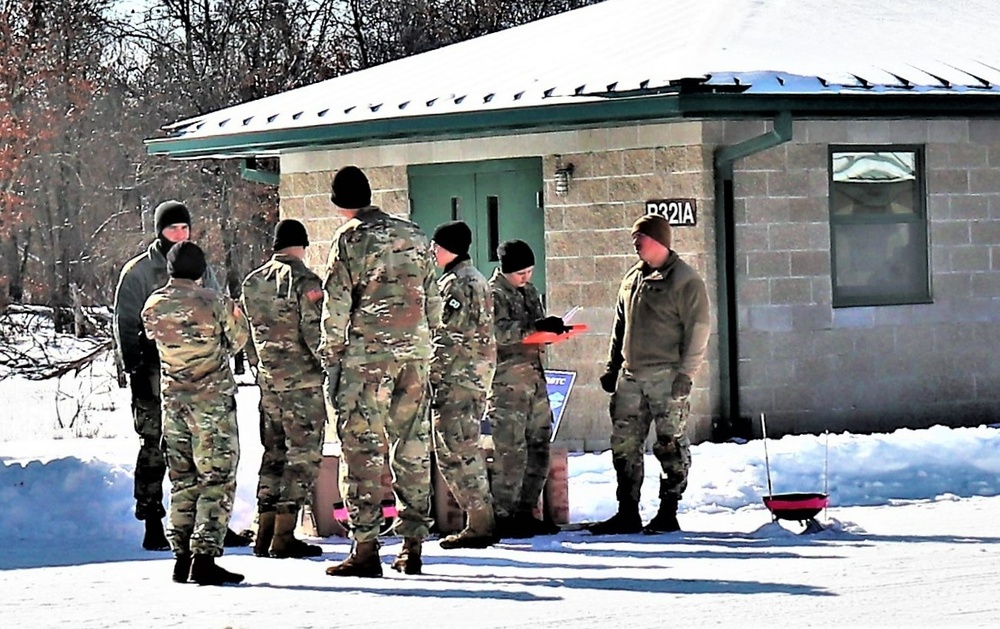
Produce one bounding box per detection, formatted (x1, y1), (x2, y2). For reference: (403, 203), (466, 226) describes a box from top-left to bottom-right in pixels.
(241, 220), (326, 557)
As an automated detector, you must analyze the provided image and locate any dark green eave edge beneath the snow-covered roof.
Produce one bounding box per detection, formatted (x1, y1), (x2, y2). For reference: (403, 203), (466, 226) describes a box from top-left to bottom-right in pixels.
(146, 90), (1000, 159)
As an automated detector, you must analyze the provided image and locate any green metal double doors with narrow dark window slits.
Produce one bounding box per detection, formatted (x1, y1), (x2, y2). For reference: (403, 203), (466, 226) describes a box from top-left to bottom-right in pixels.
(408, 158), (545, 293)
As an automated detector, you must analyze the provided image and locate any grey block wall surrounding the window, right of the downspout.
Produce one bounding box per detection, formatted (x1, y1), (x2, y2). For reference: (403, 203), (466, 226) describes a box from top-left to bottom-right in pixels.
(714, 120), (1000, 435)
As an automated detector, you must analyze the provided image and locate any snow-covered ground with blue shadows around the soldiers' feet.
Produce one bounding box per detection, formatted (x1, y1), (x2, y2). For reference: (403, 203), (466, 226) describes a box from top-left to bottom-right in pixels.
(0, 350), (1000, 629)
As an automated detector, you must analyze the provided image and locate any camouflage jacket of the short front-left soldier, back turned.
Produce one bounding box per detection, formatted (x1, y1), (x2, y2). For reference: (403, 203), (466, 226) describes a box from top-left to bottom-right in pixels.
(142, 278), (250, 396)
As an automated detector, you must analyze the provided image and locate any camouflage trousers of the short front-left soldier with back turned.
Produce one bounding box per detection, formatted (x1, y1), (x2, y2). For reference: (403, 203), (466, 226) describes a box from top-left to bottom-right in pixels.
(163, 394), (240, 557)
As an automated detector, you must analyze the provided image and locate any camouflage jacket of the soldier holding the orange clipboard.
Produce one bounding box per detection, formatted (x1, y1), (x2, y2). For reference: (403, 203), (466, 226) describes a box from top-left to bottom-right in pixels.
(490, 269), (545, 374)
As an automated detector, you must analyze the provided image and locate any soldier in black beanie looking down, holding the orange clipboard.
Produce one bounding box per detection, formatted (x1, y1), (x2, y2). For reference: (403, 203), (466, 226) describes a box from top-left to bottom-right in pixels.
(487, 240), (569, 537)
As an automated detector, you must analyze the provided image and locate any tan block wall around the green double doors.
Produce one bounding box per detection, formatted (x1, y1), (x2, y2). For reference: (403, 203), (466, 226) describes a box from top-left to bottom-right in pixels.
(280, 122), (718, 451)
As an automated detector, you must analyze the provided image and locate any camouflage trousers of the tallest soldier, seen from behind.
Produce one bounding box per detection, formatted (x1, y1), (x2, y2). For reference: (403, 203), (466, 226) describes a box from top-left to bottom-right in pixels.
(328, 360), (432, 542)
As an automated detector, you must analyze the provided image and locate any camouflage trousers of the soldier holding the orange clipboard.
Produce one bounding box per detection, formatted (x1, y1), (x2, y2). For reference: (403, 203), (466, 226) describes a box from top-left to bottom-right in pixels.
(488, 365), (552, 518)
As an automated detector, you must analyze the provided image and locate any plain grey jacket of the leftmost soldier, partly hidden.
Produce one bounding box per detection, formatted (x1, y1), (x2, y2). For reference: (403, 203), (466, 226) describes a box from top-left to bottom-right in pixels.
(114, 240), (219, 373)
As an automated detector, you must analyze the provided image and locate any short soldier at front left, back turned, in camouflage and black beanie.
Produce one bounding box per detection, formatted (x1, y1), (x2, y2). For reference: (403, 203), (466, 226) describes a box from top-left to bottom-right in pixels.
(142, 241), (250, 585)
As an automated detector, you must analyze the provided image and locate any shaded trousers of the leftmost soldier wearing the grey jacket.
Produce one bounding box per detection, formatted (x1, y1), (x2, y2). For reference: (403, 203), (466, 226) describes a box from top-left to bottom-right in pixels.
(132, 374), (167, 520)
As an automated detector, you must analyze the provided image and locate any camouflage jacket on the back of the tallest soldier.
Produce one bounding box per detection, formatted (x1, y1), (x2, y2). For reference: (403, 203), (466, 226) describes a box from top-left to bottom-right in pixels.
(321, 206), (441, 365)
